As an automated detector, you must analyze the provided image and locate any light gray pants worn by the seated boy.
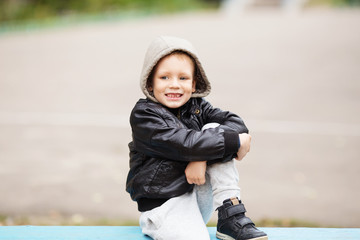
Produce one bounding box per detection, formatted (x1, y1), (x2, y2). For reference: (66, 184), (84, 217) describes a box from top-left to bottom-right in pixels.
(140, 124), (240, 240)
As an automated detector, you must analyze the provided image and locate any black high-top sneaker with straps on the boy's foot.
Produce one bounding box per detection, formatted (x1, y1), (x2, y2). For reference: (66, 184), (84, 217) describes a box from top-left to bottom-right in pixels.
(216, 198), (268, 240)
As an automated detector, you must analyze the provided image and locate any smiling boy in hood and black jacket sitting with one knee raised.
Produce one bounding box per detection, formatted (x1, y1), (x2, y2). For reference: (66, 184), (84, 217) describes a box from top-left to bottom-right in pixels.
(126, 37), (267, 240)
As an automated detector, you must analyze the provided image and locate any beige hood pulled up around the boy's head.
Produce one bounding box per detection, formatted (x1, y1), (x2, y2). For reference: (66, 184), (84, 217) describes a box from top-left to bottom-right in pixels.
(140, 36), (211, 102)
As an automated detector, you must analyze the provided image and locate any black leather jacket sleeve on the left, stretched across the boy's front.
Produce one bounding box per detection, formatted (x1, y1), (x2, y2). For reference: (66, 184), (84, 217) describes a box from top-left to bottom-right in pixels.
(130, 102), (238, 161)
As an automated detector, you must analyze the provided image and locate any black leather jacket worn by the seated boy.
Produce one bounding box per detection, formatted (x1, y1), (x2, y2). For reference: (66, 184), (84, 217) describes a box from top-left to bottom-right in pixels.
(126, 98), (248, 211)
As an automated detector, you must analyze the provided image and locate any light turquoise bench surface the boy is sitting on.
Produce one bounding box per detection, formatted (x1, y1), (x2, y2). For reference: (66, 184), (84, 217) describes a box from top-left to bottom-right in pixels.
(0, 226), (360, 240)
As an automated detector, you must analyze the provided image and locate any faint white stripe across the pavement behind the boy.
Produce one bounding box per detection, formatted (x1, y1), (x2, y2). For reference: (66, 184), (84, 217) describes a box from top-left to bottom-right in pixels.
(0, 112), (360, 137)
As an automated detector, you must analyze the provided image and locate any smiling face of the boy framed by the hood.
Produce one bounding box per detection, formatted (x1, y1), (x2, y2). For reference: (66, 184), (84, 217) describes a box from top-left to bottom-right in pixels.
(150, 54), (195, 108)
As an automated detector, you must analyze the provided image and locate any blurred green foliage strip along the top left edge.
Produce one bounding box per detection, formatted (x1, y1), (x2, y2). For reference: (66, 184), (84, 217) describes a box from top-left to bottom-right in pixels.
(0, 0), (216, 23)
